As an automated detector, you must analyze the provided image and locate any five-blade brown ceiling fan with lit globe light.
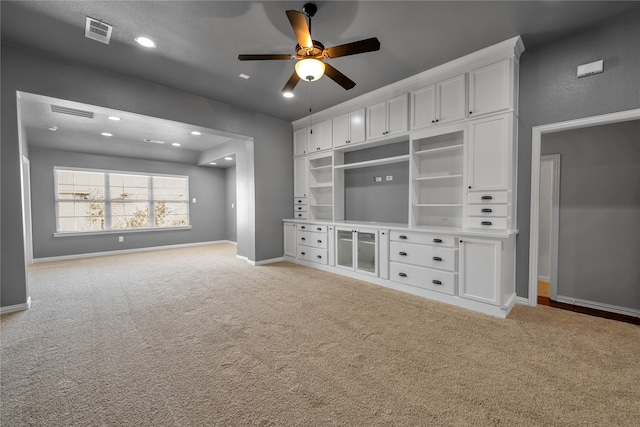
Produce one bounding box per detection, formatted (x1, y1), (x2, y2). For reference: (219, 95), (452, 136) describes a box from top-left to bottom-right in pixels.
(238, 3), (380, 95)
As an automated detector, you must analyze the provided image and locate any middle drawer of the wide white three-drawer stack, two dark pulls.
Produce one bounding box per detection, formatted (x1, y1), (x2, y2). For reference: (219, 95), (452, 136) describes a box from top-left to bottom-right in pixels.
(391, 242), (456, 271)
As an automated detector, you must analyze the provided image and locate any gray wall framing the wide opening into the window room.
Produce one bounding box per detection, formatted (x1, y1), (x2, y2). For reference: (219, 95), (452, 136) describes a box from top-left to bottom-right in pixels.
(0, 43), (293, 307)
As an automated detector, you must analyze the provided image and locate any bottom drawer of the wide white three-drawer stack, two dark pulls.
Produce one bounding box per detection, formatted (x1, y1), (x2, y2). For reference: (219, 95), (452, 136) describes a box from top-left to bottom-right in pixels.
(389, 262), (457, 295)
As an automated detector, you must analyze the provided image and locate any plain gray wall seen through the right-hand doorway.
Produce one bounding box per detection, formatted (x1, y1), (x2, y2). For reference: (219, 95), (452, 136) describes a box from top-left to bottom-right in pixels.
(541, 120), (640, 310)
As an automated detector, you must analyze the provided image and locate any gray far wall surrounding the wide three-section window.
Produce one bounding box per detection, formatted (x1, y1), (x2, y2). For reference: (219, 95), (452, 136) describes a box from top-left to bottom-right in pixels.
(30, 148), (227, 259)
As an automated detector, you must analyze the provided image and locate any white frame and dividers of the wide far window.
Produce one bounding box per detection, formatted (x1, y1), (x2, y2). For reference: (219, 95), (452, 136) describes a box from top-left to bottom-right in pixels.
(53, 166), (191, 237)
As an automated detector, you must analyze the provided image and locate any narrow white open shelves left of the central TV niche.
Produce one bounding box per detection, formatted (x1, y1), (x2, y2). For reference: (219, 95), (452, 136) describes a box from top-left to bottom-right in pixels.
(308, 152), (333, 221)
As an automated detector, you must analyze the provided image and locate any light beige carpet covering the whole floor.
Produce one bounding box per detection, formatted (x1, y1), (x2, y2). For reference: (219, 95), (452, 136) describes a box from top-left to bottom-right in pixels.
(1, 244), (640, 426)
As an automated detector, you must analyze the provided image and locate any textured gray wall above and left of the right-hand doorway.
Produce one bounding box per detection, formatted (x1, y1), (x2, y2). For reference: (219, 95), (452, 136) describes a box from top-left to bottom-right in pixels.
(516, 12), (640, 298)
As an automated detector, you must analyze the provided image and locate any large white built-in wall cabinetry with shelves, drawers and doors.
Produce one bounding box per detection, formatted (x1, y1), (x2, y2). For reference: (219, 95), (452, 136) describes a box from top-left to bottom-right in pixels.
(284, 37), (524, 317)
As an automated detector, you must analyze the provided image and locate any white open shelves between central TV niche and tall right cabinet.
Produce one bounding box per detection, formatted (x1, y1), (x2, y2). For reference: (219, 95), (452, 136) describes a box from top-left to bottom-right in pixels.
(409, 125), (467, 228)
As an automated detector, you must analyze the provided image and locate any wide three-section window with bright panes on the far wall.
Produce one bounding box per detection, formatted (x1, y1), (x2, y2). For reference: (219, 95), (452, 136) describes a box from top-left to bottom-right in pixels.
(54, 167), (189, 233)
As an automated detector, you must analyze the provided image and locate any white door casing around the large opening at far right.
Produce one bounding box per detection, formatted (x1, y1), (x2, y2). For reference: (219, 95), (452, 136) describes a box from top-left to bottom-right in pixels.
(528, 108), (640, 307)
